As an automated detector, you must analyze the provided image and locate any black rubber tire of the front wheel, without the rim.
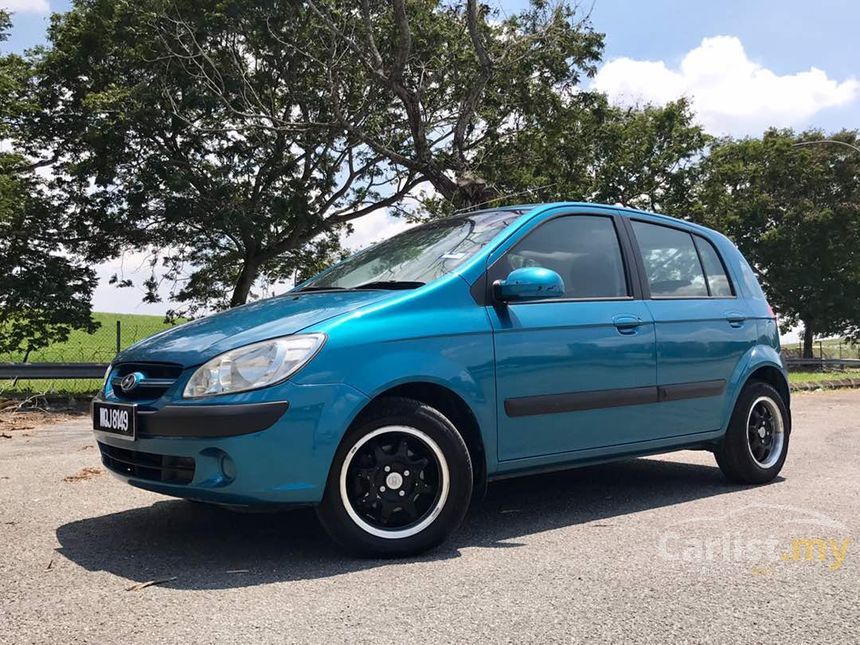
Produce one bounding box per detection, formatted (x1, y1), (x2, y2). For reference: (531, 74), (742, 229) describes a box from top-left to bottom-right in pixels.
(317, 398), (472, 557)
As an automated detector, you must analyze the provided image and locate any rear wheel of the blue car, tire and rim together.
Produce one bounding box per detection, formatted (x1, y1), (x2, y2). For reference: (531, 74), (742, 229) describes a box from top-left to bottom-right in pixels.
(714, 381), (791, 484)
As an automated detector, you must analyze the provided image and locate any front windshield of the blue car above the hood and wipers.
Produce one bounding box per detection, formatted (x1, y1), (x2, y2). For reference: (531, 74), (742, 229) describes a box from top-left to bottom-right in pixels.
(300, 211), (523, 291)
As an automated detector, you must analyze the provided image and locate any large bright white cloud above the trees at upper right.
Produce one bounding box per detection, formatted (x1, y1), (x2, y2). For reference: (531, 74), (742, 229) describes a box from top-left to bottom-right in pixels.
(594, 36), (860, 135)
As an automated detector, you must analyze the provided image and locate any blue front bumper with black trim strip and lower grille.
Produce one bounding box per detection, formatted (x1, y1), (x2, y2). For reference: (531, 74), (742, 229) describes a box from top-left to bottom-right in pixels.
(94, 384), (367, 505)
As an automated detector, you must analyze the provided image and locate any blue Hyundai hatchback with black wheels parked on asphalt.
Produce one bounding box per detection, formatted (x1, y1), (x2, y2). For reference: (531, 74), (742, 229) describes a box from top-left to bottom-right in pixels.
(93, 203), (790, 555)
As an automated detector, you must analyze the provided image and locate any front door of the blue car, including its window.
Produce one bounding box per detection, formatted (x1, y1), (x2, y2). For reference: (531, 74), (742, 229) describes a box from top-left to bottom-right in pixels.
(488, 209), (657, 461)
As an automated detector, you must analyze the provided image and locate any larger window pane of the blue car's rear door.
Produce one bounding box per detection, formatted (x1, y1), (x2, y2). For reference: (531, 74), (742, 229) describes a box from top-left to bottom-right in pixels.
(631, 221), (708, 298)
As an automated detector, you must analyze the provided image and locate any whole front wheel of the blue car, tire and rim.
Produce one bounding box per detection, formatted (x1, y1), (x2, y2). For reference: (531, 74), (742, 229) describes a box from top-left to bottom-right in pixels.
(317, 397), (472, 557)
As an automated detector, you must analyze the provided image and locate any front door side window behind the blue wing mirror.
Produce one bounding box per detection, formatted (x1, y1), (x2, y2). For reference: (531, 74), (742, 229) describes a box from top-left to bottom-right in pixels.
(492, 215), (628, 298)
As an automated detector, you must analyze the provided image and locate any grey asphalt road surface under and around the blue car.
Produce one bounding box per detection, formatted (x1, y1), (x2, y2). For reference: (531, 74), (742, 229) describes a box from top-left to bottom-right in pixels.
(0, 390), (860, 643)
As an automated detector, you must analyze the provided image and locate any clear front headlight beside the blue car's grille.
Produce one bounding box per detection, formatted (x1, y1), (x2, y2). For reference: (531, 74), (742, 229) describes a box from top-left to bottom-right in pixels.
(182, 334), (325, 399)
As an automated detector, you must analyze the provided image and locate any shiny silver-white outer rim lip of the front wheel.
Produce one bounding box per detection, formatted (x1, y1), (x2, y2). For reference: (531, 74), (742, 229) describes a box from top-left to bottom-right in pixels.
(340, 426), (451, 540)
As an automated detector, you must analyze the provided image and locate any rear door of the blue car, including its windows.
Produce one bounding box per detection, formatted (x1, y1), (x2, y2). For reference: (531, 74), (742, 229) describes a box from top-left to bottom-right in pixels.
(628, 219), (756, 437)
